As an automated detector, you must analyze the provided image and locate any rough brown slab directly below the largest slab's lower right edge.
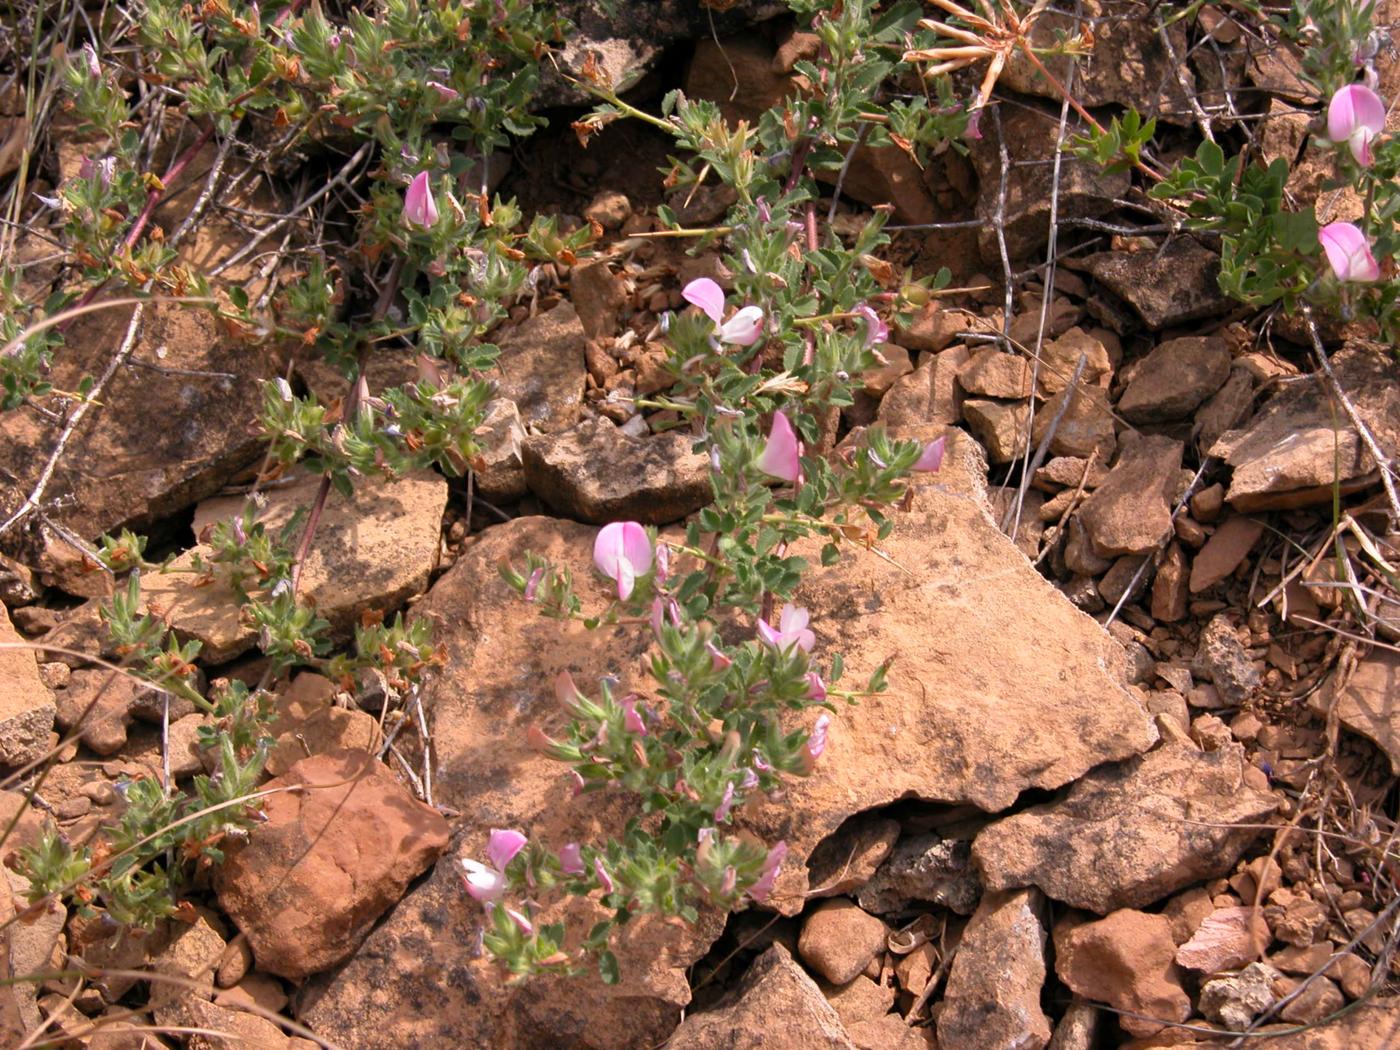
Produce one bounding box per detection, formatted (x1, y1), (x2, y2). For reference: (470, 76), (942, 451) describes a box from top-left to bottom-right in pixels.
(972, 743), (1278, 916)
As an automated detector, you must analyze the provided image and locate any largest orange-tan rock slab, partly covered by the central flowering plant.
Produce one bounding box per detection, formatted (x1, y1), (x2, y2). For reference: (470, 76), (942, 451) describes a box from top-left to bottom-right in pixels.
(302, 428), (1156, 1050)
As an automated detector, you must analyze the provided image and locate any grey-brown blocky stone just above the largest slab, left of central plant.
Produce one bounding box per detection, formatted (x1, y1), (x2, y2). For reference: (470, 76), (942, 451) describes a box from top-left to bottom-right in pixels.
(522, 419), (713, 525)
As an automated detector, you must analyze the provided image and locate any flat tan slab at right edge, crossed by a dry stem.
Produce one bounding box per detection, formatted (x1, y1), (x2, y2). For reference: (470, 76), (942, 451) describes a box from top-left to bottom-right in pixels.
(1210, 343), (1400, 512)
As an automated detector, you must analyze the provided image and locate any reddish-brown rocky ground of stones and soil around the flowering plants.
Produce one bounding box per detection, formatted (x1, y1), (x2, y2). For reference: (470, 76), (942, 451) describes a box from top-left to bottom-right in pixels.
(0, 8), (1400, 1050)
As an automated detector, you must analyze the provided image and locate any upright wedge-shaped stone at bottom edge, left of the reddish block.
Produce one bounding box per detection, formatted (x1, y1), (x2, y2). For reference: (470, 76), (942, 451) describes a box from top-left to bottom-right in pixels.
(938, 889), (1050, 1050)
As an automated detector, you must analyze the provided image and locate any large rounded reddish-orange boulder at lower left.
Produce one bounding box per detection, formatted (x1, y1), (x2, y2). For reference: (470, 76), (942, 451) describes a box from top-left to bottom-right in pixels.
(214, 750), (448, 980)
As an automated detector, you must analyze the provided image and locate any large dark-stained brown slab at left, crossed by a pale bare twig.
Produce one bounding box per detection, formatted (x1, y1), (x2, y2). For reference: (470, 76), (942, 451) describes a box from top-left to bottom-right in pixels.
(0, 304), (276, 549)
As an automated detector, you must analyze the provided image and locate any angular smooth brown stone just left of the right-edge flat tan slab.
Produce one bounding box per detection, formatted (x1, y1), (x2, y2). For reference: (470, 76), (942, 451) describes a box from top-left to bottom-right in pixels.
(1079, 434), (1183, 557)
